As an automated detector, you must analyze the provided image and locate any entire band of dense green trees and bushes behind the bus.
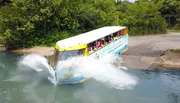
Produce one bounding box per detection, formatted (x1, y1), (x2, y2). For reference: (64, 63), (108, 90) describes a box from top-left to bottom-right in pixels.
(0, 0), (180, 49)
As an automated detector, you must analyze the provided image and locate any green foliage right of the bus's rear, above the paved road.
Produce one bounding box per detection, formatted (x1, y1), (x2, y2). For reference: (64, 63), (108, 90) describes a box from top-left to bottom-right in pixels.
(117, 0), (166, 35)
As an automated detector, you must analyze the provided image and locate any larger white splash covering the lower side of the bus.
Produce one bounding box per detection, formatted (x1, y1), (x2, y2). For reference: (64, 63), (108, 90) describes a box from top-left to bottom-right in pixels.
(57, 55), (137, 89)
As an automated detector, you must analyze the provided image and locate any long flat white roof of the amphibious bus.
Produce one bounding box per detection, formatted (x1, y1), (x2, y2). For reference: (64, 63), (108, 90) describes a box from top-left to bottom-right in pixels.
(56, 26), (126, 48)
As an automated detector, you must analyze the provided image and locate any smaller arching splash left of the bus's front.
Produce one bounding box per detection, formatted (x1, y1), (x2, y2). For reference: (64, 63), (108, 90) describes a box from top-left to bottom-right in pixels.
(8, 54), (55, 84)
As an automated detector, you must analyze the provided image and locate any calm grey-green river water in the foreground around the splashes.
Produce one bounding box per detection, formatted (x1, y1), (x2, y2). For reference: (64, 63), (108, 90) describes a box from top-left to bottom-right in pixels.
(0, 53), (180, 103)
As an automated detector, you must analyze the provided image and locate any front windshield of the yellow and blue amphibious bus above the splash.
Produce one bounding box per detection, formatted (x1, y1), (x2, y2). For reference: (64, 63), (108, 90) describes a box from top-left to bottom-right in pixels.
(57, 49), (83, 61)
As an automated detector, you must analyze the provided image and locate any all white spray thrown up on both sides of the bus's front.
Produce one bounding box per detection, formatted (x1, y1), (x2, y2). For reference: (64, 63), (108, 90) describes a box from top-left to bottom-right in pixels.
(15, 54), (137, 89)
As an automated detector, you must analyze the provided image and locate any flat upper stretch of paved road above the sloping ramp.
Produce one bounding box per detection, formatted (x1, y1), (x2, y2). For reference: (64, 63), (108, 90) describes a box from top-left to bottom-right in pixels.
(126, 33), (180, 56)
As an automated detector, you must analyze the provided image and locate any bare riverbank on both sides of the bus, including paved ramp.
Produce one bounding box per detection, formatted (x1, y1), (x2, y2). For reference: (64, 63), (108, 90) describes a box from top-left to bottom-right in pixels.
(11, 33), (180, 69)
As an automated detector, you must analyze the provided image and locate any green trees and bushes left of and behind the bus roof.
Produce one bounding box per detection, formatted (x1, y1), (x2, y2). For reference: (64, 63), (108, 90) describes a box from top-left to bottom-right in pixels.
(0, 0), (119, 49)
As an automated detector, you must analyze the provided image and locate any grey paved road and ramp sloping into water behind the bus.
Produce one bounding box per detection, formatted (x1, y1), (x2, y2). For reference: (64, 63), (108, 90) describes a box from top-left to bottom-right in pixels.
(123, 33), (180, 69)
